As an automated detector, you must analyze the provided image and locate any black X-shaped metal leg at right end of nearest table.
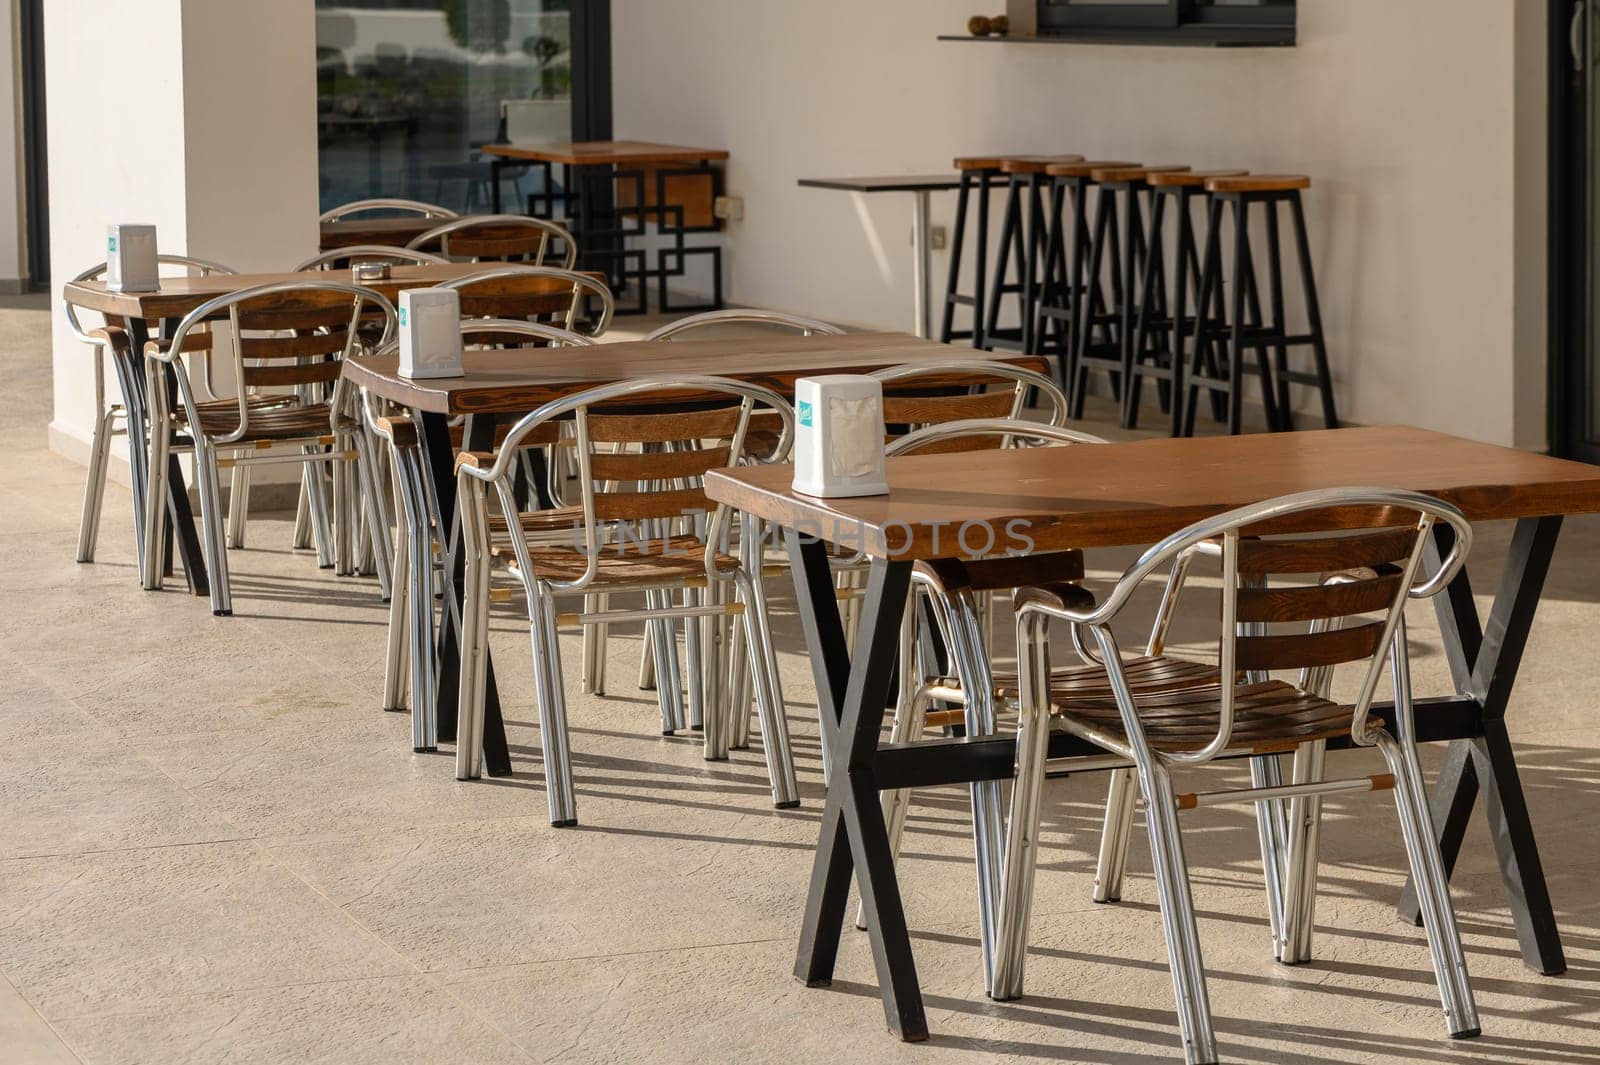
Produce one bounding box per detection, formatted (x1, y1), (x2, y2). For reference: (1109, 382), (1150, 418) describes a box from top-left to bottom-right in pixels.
(1400, 515), (1566, 975)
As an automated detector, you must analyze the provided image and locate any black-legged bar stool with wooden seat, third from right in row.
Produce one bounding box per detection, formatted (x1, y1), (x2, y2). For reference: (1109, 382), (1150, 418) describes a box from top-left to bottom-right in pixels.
(1072, 165), (1189, 417)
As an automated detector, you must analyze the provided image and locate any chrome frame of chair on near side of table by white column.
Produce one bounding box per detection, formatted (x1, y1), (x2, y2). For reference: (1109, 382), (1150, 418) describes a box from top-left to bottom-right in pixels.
(142, 280), (395, 616)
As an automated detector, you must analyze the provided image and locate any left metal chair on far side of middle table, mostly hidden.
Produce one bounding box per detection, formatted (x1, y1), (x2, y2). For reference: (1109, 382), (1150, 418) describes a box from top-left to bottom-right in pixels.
(362, 318), (594, 738)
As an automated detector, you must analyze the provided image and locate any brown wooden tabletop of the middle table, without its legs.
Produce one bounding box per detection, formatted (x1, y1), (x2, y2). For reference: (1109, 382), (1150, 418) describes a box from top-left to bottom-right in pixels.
(344, 333), (1046, 414)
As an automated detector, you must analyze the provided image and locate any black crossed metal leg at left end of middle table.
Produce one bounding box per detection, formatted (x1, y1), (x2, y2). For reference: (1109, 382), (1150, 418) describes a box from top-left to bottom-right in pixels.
(418, 413), (510, 777)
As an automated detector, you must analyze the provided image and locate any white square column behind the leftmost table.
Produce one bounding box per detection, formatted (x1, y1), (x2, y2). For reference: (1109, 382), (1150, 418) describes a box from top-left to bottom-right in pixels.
(45, 0), (317, 481)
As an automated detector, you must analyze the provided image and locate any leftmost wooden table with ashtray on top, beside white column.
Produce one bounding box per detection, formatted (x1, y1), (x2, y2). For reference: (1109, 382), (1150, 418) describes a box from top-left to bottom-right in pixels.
(62, 262), (588, 595)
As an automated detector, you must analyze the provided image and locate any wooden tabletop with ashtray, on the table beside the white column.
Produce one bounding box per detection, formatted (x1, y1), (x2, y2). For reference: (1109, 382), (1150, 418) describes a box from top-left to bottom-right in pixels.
(62, 262), (592, 321)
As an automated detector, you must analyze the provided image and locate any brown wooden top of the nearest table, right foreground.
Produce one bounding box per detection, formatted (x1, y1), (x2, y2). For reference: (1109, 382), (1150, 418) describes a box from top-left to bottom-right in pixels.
(706, 425), (1600, 560)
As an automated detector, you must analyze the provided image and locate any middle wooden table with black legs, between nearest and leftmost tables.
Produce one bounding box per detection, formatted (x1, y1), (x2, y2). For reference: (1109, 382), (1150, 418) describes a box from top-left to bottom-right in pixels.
(344, 333), (1046, 776)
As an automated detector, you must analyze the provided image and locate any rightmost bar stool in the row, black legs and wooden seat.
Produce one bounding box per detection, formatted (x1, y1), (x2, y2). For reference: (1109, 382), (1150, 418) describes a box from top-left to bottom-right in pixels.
(1184, 174), (1339, 433)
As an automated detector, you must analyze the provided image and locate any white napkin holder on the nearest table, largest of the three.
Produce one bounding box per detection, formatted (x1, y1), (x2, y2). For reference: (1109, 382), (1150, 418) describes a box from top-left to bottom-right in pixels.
(794, 374), (890, 499)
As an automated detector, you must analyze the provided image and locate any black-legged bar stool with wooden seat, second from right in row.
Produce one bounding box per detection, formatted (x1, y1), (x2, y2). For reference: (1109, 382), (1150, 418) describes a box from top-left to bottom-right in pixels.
(1122, 170), (1248, 437)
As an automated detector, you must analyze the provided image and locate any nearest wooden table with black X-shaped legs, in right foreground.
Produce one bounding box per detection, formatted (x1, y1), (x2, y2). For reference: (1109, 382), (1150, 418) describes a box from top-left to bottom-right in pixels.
(706, 427), (1600, 1039)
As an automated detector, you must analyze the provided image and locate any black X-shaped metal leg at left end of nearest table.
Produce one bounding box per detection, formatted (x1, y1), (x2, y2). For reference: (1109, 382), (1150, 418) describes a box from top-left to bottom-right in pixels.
(786, 531), (928, 1043)
